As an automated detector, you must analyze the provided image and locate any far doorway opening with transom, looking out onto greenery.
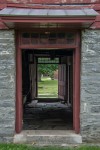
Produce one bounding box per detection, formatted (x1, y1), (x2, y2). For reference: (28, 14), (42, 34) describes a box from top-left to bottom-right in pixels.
(37, 56), (60, 99)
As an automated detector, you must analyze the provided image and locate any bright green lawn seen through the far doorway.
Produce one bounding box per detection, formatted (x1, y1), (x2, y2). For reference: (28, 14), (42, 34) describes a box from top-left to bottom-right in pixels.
(38, 77), (58, 98)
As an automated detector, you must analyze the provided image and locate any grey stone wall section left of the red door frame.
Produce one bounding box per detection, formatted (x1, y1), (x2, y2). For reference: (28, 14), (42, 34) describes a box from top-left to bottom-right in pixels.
(0, 30), (16, 142)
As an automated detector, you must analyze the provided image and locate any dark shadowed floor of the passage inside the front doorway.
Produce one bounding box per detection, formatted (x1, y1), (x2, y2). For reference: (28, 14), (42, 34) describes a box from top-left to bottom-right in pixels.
(23, 102), (73, 130)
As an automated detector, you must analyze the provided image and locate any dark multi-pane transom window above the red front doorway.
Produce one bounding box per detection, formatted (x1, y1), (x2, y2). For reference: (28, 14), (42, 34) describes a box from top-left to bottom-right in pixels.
(21, 32), (75, 45)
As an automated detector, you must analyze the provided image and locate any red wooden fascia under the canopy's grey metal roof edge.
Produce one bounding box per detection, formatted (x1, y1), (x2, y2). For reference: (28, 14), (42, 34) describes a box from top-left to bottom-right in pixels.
(1, 16), (96, 28)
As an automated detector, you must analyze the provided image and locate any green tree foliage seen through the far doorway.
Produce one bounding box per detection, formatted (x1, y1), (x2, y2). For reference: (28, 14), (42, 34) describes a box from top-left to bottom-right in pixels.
(38, 64), (58, 81)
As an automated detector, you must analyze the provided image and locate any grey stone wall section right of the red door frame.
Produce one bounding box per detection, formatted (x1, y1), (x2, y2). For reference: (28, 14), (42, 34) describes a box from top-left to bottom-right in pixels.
(80, 30), (100, 142)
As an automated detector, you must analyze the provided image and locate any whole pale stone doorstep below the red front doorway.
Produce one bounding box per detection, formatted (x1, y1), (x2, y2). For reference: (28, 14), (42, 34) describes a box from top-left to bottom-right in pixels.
(14, 130), (82, 145)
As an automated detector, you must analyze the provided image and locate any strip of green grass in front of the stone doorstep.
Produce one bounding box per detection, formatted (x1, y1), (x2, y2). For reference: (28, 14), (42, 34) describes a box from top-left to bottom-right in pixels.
(0, 144), (100, 150)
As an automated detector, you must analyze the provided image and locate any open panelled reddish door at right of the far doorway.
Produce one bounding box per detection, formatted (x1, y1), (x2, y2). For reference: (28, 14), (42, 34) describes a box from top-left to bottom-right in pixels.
(58, 64), (66, 100)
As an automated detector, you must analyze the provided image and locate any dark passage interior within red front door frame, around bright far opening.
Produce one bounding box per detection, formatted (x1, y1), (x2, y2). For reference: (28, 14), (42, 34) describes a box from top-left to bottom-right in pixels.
(22, 49), (73, 130)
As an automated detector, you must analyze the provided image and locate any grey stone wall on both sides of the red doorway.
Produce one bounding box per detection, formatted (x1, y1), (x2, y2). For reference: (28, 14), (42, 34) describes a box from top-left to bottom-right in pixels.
(0, 30), (100, 142)
